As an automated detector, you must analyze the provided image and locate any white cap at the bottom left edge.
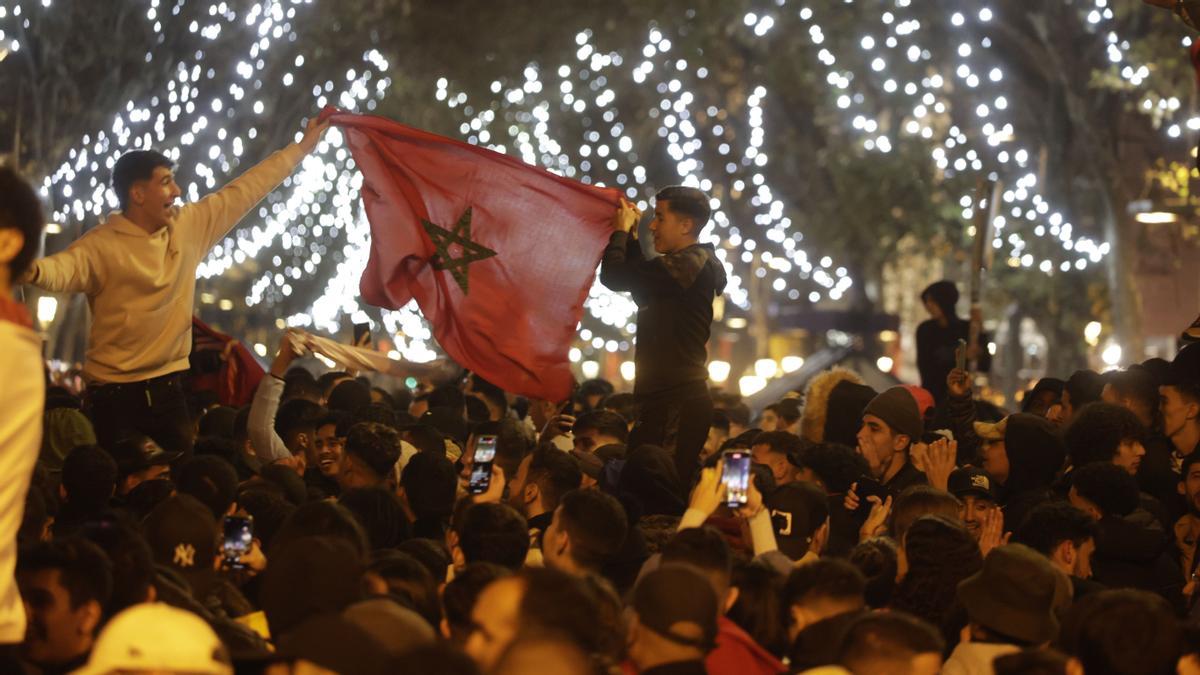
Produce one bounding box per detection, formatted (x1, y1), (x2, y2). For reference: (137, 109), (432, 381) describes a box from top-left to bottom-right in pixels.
(73, 603), (233, 675)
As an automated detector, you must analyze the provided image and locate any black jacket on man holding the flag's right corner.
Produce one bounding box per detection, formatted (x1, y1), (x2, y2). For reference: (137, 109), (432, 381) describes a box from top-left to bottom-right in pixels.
(600, 232), (726, 400)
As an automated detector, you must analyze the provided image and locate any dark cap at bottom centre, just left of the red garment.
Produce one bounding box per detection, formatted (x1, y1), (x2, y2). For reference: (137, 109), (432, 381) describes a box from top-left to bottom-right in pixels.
(630, 565), (718, 651)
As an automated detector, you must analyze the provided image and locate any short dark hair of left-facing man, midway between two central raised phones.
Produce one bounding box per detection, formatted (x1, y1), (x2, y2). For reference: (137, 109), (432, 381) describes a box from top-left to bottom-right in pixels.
(558, 490), (629, 569)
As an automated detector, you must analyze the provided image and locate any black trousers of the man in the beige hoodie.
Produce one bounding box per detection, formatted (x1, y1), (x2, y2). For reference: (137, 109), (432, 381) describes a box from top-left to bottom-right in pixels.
(86, 372), (196, 459)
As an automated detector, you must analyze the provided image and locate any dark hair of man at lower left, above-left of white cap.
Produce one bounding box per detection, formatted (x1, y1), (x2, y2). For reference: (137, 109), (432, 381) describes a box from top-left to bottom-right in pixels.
(17, 537), (113, 611)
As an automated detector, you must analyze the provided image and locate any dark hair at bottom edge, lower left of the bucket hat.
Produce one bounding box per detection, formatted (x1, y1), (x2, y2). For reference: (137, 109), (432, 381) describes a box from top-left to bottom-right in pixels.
(838, 611), (946, 673)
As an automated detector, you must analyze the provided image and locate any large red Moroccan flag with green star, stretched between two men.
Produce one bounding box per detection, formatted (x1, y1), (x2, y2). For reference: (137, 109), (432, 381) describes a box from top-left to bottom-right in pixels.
(328, 112), (620, 401)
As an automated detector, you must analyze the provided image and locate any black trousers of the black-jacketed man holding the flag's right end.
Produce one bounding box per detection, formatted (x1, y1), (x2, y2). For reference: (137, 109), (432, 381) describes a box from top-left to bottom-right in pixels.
(629, 389), (713, 487)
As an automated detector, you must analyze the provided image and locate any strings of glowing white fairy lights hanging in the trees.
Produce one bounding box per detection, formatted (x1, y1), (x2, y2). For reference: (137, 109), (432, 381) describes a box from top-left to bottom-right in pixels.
(7, 0), (1200, 375)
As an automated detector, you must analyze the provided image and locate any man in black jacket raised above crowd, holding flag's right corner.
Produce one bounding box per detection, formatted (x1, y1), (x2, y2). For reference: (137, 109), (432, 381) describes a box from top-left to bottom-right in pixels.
(600, 186), (726, 479)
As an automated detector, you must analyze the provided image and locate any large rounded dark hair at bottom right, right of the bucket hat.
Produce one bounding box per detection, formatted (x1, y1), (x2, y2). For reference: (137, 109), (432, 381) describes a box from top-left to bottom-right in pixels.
(1070, 590), (1183, 675)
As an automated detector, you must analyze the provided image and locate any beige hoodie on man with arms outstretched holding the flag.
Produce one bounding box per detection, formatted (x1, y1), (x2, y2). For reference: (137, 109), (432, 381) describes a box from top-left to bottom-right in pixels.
(30, 144), (304, 384)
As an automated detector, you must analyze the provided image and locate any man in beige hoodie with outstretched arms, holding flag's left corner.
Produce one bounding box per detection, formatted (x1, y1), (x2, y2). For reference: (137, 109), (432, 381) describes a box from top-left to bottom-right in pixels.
(24, 119), (329, 455)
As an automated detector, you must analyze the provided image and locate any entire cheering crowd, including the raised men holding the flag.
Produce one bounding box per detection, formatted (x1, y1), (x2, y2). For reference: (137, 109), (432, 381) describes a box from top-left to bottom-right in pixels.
(0, 109), (1200, 675)
